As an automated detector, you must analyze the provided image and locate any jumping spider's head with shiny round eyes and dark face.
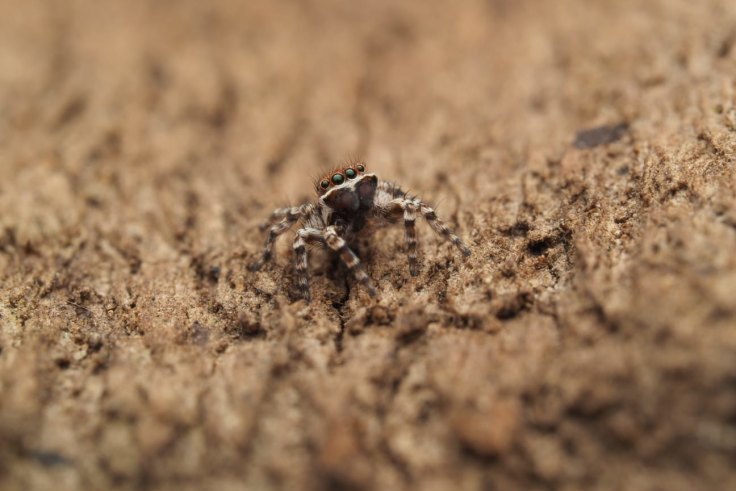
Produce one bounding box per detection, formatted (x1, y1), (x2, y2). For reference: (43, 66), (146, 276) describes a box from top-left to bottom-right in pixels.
(317, 163), (378, 214)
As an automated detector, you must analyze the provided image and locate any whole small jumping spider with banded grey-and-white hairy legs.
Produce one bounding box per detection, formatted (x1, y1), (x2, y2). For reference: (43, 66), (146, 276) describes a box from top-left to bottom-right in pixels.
(248, 162), (470, 302)
